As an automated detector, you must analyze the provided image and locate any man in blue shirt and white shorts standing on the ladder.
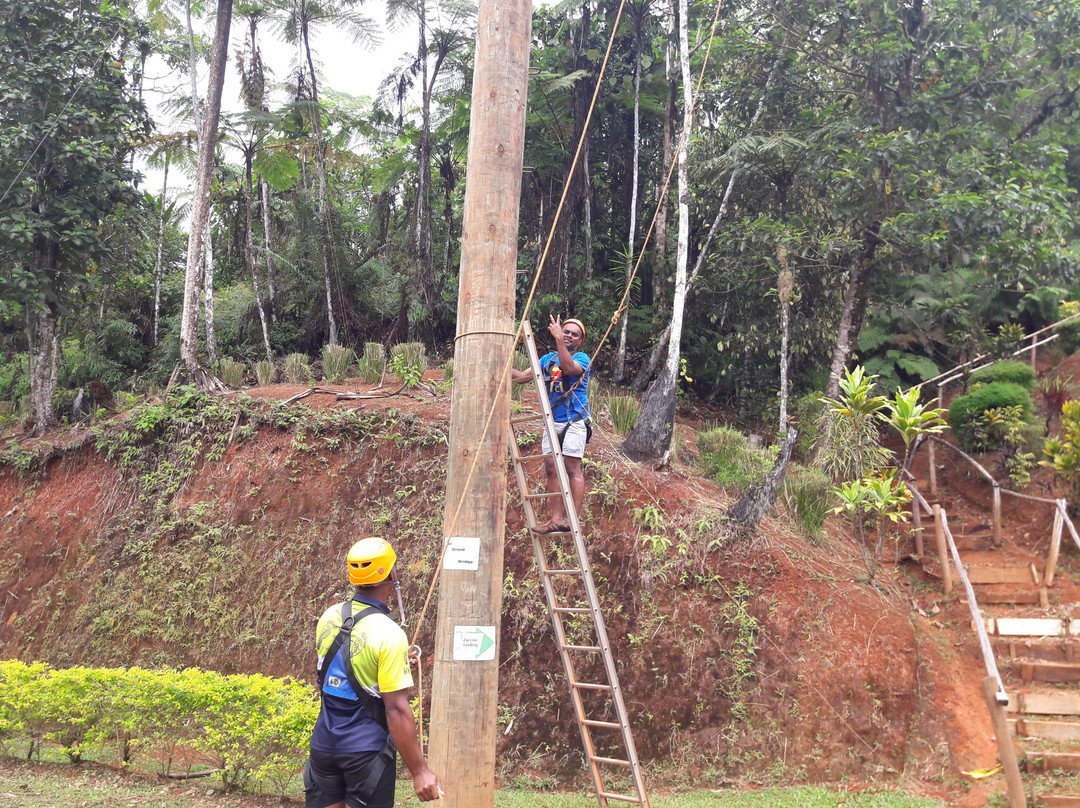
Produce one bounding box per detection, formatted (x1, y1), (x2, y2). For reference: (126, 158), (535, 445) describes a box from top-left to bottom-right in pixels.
(511, 317), (592, 533)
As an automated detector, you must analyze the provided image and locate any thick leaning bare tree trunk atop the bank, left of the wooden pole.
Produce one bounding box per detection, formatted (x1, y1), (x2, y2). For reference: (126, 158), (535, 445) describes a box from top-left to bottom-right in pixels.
(180, 0), (232, 388)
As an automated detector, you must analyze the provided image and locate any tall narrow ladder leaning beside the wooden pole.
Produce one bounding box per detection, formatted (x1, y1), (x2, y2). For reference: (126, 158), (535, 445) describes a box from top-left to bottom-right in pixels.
(509, 320), (649, 808)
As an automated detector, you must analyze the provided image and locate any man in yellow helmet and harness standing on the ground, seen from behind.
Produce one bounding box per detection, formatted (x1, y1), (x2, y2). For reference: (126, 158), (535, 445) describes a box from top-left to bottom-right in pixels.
(303, 538), (442, 808)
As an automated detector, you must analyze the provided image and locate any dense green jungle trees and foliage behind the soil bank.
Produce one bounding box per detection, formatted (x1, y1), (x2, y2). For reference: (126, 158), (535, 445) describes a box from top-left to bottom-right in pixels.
(0, 0), (1080, 429)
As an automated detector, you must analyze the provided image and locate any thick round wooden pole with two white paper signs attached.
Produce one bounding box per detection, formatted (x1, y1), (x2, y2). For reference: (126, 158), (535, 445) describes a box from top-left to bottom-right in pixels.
(430, 0), (532, 808)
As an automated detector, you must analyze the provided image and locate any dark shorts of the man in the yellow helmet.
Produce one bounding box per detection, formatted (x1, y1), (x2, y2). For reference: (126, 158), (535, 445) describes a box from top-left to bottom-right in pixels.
(303, 749), (397, 808)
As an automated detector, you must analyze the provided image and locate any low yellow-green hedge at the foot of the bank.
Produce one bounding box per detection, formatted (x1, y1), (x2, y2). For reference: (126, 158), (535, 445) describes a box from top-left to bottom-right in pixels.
(0, 660), (319, 795)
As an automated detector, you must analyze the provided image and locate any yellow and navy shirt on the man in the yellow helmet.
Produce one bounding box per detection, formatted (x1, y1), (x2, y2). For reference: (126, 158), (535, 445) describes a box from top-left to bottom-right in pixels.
(311, 594), (413, 753)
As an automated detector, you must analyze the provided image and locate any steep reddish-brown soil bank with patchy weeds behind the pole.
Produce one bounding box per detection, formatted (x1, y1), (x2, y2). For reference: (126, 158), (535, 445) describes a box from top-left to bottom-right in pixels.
(0, 386), (996, 798)
